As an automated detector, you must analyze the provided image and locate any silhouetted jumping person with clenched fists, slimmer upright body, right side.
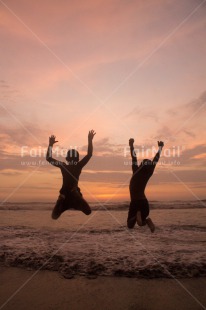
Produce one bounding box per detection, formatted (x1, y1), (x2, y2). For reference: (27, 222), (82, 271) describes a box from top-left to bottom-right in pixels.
(127, 139), (164, 232)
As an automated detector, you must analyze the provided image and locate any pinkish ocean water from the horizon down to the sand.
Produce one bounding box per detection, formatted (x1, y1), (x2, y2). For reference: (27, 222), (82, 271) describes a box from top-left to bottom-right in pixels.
(0, 200), (206, 278)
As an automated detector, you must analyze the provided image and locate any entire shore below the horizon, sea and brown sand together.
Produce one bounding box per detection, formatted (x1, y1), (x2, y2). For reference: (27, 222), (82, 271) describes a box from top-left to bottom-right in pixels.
(0, 203), (206, 310)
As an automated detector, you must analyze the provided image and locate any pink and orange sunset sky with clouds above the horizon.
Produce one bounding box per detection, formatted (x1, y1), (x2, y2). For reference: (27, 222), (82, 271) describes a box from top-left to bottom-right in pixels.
(0, 0), (206, 203)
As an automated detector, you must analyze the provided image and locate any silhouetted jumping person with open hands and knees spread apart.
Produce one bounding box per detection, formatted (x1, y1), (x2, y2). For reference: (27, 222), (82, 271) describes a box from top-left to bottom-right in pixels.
(46, 130), (96, 220)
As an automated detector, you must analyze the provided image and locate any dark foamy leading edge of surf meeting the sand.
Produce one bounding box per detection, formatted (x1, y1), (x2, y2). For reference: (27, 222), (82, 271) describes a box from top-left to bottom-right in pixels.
(0, 252), (206, 279)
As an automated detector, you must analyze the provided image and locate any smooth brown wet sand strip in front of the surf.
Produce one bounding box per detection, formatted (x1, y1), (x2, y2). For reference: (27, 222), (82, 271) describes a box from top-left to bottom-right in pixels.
(0, 267), (206, 310)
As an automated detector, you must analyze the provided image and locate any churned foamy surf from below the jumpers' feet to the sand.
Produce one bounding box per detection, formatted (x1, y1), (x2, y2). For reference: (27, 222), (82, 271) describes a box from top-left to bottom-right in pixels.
(0, 225), (206, 278)
